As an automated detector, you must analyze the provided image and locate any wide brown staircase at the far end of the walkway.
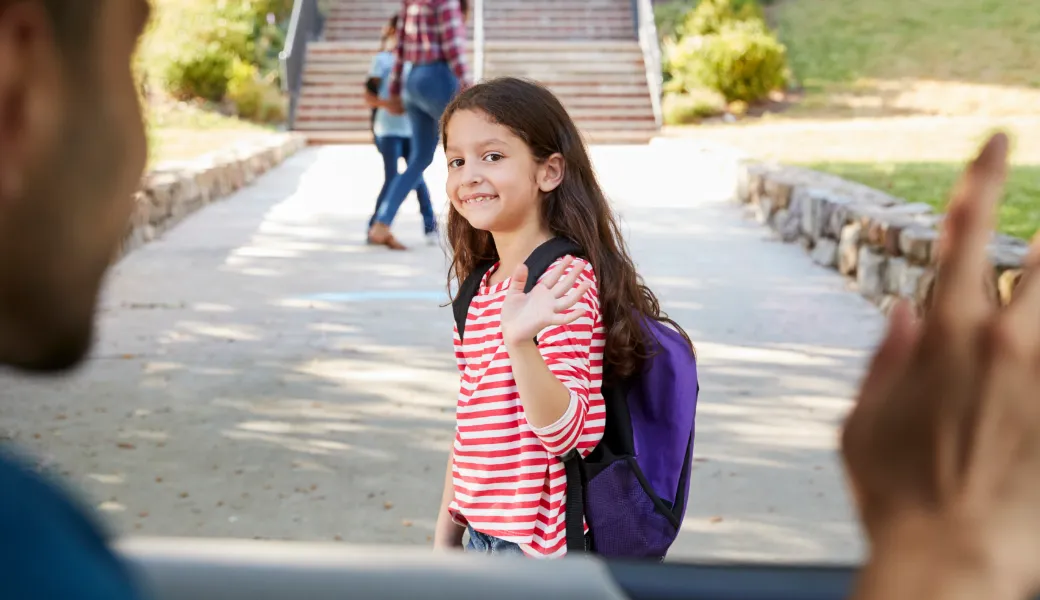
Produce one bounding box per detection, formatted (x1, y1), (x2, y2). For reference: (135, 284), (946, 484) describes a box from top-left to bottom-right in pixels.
(293, 0), (658, 144)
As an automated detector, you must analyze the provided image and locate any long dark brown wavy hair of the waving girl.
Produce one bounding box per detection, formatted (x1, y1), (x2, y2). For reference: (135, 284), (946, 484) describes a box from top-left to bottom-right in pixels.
(441, 77), (693, 379)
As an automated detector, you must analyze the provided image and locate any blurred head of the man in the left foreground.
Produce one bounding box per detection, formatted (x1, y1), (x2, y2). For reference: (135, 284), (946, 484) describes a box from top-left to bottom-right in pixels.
(0, 0), (148, 370)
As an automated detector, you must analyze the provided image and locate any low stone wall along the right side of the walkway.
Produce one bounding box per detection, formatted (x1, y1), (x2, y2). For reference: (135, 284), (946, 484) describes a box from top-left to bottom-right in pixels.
(736, 162), (1029, 312)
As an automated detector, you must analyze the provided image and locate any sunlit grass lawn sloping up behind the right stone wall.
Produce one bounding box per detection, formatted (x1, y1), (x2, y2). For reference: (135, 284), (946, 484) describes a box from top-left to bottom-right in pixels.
(665, 0), (1040, 238)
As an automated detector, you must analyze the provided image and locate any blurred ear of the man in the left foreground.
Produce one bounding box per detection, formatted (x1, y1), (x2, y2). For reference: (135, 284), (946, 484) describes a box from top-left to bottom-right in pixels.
(0, 2), (66, 199)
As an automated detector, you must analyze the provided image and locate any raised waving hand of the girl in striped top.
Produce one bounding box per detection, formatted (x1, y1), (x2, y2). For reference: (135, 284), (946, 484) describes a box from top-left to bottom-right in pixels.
(500, 257), (592, 345)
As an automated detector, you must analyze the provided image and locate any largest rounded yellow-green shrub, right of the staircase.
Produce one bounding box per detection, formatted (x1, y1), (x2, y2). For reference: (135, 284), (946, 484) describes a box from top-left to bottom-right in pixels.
(668, 21), (787, 103)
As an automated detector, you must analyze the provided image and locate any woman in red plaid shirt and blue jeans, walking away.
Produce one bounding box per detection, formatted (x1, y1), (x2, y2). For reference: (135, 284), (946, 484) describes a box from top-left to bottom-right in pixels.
(368, 0), (471, 250)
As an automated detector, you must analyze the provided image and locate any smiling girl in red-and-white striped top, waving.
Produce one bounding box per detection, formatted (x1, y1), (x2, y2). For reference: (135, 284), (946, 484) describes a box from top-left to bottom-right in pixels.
(434, 78), (688, 556)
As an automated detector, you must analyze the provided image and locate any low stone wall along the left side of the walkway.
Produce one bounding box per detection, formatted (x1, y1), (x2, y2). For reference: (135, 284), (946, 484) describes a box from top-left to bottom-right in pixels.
(115, 133), (307, 260)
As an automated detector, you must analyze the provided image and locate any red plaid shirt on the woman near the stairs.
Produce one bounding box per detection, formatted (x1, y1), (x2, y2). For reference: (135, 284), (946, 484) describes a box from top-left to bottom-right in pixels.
(390, 0), (469, 96)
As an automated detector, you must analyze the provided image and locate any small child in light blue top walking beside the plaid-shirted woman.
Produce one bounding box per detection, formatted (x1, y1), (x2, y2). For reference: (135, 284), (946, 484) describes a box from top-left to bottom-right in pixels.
(365, 15), (440, 250)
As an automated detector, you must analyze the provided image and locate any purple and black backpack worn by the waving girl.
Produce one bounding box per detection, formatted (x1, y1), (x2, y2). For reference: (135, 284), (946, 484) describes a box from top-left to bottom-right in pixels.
(451, 238), (700, 558)
